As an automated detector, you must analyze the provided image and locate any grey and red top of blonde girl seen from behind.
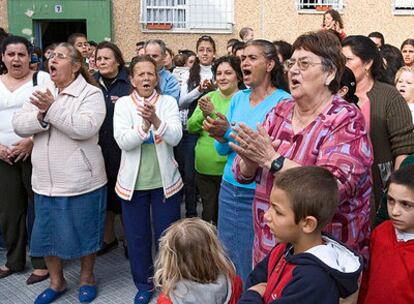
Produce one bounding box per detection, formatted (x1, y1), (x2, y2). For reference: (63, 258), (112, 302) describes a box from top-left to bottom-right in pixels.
(157, 275), (243, 304)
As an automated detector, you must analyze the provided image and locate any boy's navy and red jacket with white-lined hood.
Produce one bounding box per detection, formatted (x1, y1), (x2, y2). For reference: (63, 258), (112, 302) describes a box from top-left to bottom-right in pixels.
(238, 236), (362, 304)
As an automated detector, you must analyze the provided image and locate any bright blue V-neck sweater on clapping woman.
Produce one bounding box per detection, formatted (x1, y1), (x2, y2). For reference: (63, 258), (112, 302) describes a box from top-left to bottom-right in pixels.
(214, 89), (290, 189)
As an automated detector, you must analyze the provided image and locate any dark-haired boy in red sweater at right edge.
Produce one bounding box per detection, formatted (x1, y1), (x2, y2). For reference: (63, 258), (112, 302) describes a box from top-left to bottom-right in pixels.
(358, 165), (414, 304)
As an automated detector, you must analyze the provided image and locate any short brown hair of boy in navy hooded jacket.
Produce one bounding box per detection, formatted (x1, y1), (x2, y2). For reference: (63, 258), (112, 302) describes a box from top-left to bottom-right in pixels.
(273, 166), (339, 231)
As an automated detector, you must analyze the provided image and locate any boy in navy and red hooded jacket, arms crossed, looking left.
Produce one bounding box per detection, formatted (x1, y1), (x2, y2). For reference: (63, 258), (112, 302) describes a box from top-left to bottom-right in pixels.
(239, 167), (362, 304)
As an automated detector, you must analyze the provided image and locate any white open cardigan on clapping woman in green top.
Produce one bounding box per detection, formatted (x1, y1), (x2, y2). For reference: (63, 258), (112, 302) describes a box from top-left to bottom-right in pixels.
(114, 94), (183, 200)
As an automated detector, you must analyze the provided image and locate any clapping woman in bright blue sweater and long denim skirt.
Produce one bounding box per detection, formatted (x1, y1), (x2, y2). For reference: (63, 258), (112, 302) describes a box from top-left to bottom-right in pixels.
(203, 39), (290, 282)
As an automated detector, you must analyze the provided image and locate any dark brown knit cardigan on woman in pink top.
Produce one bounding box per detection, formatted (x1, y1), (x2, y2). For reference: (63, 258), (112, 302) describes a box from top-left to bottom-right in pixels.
(367, 81), (414, 206)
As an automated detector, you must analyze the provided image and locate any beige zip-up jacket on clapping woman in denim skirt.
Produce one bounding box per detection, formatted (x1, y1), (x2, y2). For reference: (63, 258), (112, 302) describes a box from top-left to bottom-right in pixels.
(13, 75), (107, 196)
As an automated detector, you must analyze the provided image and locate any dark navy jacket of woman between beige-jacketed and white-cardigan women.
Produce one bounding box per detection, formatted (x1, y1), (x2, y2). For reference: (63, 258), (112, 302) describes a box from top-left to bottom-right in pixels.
(95, 68), (132, 177)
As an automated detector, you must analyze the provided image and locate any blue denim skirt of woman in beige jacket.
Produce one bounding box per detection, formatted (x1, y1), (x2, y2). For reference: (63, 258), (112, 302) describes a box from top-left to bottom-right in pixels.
(30, 186), (106, 259)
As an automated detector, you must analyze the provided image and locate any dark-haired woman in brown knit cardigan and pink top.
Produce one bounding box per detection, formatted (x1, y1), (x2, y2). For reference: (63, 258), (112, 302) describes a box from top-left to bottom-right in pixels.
(342, 35), (414, 211)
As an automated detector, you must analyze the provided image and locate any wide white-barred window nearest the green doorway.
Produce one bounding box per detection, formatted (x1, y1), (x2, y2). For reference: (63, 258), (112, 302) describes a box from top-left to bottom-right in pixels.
(141, 0), (234, 32)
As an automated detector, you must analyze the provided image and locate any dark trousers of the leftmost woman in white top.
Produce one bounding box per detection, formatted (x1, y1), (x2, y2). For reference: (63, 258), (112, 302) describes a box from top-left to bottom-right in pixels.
(0, 159), (46, 272)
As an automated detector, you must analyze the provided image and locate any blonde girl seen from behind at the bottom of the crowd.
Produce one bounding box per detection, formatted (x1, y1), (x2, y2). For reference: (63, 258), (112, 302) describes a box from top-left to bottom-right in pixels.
(154, 218), (242, 304)
